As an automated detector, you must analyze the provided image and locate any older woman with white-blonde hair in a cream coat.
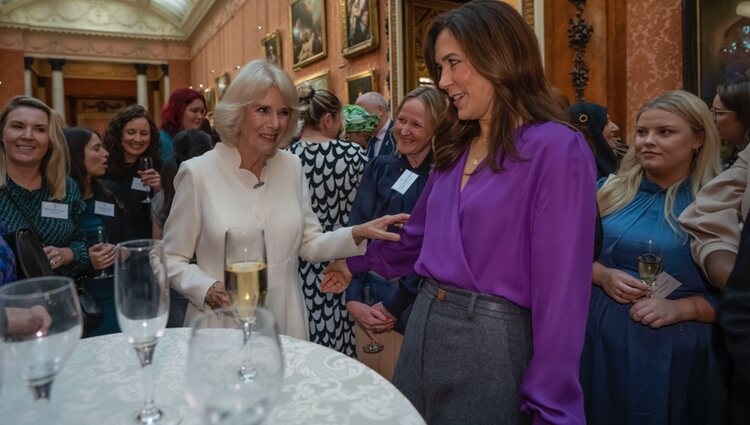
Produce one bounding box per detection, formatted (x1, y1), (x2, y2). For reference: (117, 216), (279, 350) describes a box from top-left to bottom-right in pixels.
(164, 60), (407, 339)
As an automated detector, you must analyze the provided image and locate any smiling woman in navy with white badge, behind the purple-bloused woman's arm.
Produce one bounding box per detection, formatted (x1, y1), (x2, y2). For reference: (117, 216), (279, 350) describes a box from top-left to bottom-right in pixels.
(346, 87), (447, 342)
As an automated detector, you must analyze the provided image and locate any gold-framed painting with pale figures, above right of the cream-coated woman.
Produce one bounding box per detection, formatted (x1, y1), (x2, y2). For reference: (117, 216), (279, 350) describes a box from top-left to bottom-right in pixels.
(289, 0), (326, 68)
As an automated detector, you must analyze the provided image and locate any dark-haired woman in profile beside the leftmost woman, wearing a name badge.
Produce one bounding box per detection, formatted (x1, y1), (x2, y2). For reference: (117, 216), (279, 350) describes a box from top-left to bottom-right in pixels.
(63, 127), (132, 337)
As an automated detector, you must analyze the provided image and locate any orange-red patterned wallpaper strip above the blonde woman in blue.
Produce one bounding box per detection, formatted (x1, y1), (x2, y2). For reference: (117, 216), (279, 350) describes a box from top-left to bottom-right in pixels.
(625, 0), (682, 135)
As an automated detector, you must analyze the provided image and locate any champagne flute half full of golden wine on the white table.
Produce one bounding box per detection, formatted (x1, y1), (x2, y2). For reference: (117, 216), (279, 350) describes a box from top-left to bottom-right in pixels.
(224, 227), (268, 380)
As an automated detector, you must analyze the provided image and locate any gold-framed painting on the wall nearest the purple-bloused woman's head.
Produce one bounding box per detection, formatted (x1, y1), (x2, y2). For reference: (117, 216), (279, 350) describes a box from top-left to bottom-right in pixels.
(340, 0), (378, 57)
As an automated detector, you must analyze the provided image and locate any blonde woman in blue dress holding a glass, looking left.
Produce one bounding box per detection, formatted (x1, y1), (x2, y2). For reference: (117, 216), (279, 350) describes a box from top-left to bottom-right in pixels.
(581, 91), (727, 425)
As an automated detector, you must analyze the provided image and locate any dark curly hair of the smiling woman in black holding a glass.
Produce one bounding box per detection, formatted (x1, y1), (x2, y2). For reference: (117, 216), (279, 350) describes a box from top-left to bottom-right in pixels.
(102, 104), (161, 176)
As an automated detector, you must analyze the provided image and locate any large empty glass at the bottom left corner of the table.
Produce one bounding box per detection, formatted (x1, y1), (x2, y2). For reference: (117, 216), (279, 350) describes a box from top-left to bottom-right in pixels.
(0, 276), (83, 422)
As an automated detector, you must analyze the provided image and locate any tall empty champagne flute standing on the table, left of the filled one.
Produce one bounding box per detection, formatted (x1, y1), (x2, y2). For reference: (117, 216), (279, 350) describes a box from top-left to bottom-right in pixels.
(115, 239), (181, 425)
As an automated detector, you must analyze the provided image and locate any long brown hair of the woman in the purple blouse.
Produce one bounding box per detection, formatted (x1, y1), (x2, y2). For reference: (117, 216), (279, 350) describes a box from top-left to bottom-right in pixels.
(424, 0), (563, 171)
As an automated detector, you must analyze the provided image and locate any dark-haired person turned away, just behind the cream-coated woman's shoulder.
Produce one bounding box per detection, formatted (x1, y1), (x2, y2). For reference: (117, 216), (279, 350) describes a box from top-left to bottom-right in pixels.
(151, 129), (212, 239)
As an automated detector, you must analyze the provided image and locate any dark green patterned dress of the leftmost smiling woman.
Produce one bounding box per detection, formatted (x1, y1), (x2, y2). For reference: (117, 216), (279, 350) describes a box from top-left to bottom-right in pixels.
(0, 177), (89, 278)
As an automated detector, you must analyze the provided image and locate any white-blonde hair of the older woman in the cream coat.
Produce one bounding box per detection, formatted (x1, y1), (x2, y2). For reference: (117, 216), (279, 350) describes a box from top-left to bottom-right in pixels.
(214, 59), (299, 147)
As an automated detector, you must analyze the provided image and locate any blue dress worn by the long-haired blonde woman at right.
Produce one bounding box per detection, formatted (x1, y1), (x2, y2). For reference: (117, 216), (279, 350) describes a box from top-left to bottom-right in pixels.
(581, 179), (728, 425)
